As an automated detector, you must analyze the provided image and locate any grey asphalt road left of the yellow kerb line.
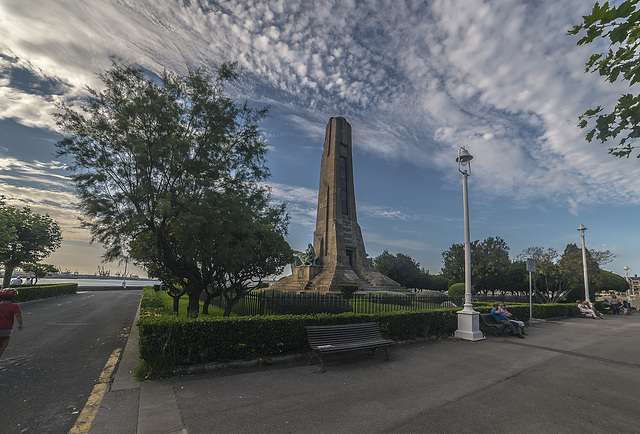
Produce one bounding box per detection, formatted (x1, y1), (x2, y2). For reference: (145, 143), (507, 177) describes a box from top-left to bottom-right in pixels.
(0, 290), (142, 434)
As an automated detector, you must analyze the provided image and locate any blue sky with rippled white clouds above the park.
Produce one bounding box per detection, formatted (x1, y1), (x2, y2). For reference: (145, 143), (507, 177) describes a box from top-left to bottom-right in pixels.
(0, 0), (640, 282)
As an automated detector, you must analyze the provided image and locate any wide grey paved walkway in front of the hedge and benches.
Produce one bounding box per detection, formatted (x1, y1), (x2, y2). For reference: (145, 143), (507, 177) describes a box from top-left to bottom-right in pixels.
(90, 314), (640, 434)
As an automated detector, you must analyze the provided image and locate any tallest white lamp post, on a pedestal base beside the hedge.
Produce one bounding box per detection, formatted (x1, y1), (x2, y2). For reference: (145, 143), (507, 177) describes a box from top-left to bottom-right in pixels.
(455, 147), (484, 341)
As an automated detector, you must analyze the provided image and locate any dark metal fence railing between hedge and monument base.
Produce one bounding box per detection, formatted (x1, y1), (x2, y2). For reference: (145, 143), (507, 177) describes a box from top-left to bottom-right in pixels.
(211, 291), (529, 316)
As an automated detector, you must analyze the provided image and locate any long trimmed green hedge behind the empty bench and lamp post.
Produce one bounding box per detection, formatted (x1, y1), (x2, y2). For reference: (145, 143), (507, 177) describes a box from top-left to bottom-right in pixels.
(138, 287), (578, 377)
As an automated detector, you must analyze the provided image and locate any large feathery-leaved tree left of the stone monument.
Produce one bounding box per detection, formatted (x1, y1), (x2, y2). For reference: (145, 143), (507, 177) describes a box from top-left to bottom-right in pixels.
(57, 64), (287, 317)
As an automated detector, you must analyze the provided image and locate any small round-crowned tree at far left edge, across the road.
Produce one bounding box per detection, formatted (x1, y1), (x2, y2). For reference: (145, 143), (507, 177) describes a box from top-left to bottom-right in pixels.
(0, 200), (62, 288)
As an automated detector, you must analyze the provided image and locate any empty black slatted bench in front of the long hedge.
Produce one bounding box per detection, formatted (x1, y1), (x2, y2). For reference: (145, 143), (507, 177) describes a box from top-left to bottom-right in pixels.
(306, 322), (395, 372)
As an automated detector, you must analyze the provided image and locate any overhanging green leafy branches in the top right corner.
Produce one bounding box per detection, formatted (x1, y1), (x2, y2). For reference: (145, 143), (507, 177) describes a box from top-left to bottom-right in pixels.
(569, 0), (640, 158)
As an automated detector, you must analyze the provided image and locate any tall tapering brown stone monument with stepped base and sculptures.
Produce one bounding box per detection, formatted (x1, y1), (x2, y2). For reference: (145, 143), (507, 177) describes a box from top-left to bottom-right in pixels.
(273, 117), (401, 292)
